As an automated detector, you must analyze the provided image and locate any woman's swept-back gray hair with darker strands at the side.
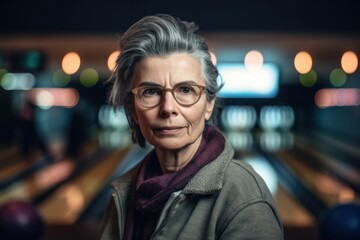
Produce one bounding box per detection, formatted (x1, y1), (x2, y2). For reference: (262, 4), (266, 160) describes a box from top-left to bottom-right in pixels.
(109, 14), (223, 147)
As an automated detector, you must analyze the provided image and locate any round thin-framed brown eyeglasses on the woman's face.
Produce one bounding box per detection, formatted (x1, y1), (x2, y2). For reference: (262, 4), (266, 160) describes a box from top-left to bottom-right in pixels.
(131, 83), (205, 108)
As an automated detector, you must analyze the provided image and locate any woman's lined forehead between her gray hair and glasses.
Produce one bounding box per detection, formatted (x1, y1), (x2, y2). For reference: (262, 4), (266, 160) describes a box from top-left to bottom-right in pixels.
(134, 53), (204, 85)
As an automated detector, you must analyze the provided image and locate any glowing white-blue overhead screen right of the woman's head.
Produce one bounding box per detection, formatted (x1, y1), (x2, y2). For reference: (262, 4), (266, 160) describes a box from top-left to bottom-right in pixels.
(217, 63), (279, 98)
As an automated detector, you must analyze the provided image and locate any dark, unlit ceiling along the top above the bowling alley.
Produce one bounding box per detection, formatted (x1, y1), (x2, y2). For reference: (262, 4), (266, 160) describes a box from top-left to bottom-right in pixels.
(0, 0), (360, 34)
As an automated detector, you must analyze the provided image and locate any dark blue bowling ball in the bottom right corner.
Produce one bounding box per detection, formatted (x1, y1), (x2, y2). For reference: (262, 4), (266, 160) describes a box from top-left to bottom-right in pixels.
(319, 203), (360, 240)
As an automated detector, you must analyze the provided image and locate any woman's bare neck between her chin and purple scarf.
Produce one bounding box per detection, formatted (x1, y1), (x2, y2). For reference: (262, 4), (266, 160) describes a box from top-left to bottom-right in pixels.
(155, 136), (202, 174)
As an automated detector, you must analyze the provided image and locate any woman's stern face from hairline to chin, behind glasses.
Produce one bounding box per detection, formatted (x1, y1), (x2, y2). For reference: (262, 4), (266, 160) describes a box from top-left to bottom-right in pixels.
(133, 53), (214, 150)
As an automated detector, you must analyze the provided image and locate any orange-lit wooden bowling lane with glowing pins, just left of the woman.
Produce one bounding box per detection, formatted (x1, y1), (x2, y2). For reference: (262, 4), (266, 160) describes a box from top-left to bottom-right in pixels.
(34, 105), (135, 223)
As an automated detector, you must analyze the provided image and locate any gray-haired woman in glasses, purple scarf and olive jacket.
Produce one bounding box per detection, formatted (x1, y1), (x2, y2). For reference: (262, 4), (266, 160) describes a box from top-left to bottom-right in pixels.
(101, 15), (282, 240)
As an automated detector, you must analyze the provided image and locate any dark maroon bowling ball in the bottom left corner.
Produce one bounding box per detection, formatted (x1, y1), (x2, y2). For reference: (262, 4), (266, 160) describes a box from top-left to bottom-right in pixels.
(0, 201), (44, 240)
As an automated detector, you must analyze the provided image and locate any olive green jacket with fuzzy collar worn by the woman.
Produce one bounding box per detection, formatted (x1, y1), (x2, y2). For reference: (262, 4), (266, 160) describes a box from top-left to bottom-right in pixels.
(100, 143), (283, 240)
